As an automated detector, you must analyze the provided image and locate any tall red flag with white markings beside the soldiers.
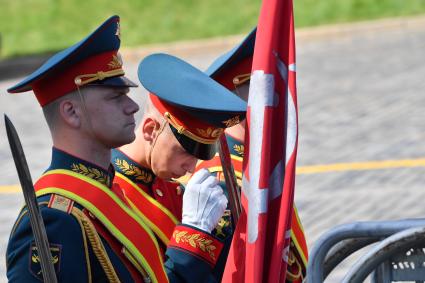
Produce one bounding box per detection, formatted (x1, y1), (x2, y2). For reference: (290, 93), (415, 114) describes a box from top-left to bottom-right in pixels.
(223, 0), (298, 282)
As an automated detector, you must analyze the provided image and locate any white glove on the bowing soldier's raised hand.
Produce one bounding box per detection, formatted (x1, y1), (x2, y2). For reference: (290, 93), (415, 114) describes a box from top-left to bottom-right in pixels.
(182, 169), (227, 233)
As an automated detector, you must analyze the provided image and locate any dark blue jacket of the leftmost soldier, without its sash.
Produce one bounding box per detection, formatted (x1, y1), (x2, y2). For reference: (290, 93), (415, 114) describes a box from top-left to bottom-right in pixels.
(6, 148), (147, 282)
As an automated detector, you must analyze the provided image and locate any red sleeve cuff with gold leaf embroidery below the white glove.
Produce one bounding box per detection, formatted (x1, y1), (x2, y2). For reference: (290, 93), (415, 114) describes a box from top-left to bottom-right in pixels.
(168, 225), (223, 267)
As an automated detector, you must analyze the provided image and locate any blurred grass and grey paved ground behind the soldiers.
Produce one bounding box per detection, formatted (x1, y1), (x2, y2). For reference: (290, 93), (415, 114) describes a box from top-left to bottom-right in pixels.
(0, 0), (425, 282)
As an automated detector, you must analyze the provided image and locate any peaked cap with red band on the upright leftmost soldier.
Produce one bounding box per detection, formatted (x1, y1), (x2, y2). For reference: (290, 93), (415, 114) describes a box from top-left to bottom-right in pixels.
(7, 16), (137, 106)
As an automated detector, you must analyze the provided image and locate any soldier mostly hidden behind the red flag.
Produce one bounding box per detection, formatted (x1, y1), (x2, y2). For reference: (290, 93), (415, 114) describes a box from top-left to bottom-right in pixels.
(196, 29), (308, 282)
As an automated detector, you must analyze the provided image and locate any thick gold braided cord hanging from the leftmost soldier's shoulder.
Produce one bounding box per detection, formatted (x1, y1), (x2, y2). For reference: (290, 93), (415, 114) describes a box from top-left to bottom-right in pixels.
(71, 207), (120, 283)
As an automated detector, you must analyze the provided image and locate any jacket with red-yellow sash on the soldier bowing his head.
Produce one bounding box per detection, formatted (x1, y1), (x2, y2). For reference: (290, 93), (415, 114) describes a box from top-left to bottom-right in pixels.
(112, 149), (223, 282)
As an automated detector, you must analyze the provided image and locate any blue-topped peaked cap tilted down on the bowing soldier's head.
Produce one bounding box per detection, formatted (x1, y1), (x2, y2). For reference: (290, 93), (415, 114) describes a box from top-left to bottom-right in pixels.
(138, 53), (247, 160)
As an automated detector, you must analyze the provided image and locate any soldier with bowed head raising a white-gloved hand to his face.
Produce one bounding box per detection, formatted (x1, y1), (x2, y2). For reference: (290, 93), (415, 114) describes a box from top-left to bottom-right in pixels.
(112, 54), (246, 282)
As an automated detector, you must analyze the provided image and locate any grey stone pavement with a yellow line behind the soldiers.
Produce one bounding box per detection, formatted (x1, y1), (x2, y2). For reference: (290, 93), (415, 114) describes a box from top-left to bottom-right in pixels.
(0, 16), (425, 282)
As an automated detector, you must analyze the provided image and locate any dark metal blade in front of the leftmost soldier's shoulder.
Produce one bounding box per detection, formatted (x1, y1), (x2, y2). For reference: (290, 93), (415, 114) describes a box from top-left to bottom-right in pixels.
(4, 115), (57, 283)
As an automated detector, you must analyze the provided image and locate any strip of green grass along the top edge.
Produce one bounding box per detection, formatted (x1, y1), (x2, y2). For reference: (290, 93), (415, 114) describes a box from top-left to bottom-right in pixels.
(0, 0), (425, 58)
